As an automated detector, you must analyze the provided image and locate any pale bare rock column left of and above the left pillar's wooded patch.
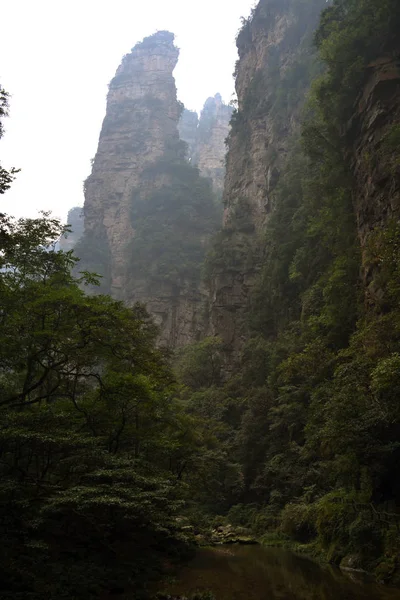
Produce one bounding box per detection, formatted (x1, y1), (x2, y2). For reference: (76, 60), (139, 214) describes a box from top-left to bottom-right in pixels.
(80, 31), (181, 299)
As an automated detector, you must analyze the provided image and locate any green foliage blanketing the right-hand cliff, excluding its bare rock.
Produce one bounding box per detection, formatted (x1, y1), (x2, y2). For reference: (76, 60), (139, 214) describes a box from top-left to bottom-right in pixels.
(182, 0), (400, 579)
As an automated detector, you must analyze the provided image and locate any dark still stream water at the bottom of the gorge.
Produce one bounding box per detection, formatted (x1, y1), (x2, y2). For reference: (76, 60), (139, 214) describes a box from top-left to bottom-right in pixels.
(162, 545), (400, 600)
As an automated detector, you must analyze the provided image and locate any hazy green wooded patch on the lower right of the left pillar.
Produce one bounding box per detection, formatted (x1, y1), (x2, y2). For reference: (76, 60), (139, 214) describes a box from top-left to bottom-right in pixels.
(129, 141), (219, 289)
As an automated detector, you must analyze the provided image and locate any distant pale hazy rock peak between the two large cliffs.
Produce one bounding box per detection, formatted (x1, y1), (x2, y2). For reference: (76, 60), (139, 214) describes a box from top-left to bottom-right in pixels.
(179, 94), (233, 198)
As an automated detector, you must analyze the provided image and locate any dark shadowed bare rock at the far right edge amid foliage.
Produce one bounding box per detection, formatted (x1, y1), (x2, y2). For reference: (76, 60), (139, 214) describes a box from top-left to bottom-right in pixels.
(346, 54), (400, 304)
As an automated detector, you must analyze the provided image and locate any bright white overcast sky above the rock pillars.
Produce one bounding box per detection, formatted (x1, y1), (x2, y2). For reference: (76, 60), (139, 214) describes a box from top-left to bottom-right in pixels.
(0, 0), (254, 220)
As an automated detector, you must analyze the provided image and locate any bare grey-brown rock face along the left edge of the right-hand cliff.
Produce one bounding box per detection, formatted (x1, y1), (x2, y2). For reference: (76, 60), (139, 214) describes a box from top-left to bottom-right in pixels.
(211, 0), (325, 353)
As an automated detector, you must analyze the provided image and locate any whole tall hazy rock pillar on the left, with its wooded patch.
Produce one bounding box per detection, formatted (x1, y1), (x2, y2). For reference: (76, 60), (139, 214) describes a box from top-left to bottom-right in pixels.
(76, 32), (216, 347)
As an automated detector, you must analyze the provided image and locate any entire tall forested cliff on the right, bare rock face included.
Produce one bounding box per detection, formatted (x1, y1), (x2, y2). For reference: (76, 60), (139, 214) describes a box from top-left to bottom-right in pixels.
(180, 0), (400, 579)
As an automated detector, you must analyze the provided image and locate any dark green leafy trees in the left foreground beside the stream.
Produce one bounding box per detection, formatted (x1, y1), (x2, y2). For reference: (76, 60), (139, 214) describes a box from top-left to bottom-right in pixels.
(0, 211), (198, 599)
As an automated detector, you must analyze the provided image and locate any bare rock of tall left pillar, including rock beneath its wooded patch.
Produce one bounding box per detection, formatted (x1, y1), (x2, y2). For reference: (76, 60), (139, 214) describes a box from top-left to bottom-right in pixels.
(77, 31), (223, 348)
